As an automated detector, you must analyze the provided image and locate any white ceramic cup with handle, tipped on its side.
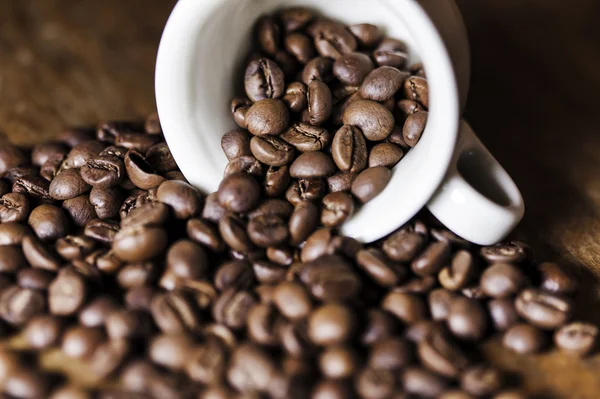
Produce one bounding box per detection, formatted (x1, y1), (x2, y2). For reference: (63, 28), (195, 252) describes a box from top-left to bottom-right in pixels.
(155, 0), (524, 245)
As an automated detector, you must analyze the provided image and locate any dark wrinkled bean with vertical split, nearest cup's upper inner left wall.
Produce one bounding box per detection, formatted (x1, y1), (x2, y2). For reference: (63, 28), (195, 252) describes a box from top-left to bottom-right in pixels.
(244, 57), (285, 102)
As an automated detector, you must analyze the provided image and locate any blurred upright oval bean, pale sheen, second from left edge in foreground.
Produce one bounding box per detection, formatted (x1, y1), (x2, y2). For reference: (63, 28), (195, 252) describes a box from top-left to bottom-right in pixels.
(48, 268), (89, 316)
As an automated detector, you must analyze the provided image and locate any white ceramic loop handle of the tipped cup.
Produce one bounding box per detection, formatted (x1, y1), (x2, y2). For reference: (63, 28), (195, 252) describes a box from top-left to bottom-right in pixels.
(427, 121), (525, 245)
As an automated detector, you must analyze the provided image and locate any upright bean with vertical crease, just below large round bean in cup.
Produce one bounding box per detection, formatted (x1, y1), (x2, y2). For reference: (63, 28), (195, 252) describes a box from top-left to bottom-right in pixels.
(331, 125), (367, 173)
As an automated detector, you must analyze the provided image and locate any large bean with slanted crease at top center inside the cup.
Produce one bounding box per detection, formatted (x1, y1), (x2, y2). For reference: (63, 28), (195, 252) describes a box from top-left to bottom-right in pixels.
(310, 20), (357, 59)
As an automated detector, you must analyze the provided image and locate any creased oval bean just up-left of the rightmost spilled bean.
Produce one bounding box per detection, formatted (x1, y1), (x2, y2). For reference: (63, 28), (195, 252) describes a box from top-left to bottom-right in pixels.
(515, 288), (573, 330)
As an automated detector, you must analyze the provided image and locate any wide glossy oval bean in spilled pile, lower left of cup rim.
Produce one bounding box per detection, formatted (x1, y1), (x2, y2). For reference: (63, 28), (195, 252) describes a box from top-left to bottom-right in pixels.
(113, 226), (168, 262)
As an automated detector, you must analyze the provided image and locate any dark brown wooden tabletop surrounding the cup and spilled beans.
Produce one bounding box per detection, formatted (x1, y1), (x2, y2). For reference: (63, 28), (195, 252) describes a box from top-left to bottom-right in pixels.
(0, 0), (600, 398)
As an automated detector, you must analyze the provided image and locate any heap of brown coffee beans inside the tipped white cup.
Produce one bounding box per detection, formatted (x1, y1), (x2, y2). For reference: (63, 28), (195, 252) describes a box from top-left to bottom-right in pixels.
(227, 8), (429, 219)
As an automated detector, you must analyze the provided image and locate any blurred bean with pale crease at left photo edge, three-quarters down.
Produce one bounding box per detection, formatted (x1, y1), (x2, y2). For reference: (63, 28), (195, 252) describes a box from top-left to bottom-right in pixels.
(0, 285), (46, 326)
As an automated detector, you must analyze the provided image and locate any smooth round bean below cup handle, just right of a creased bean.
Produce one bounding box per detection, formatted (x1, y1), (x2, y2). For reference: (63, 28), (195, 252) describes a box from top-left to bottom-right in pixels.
(480, 263), (525, 298)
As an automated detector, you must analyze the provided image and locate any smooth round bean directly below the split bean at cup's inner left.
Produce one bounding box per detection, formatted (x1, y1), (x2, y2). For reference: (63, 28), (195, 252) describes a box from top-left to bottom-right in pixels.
(246, 99), (289, 136)
